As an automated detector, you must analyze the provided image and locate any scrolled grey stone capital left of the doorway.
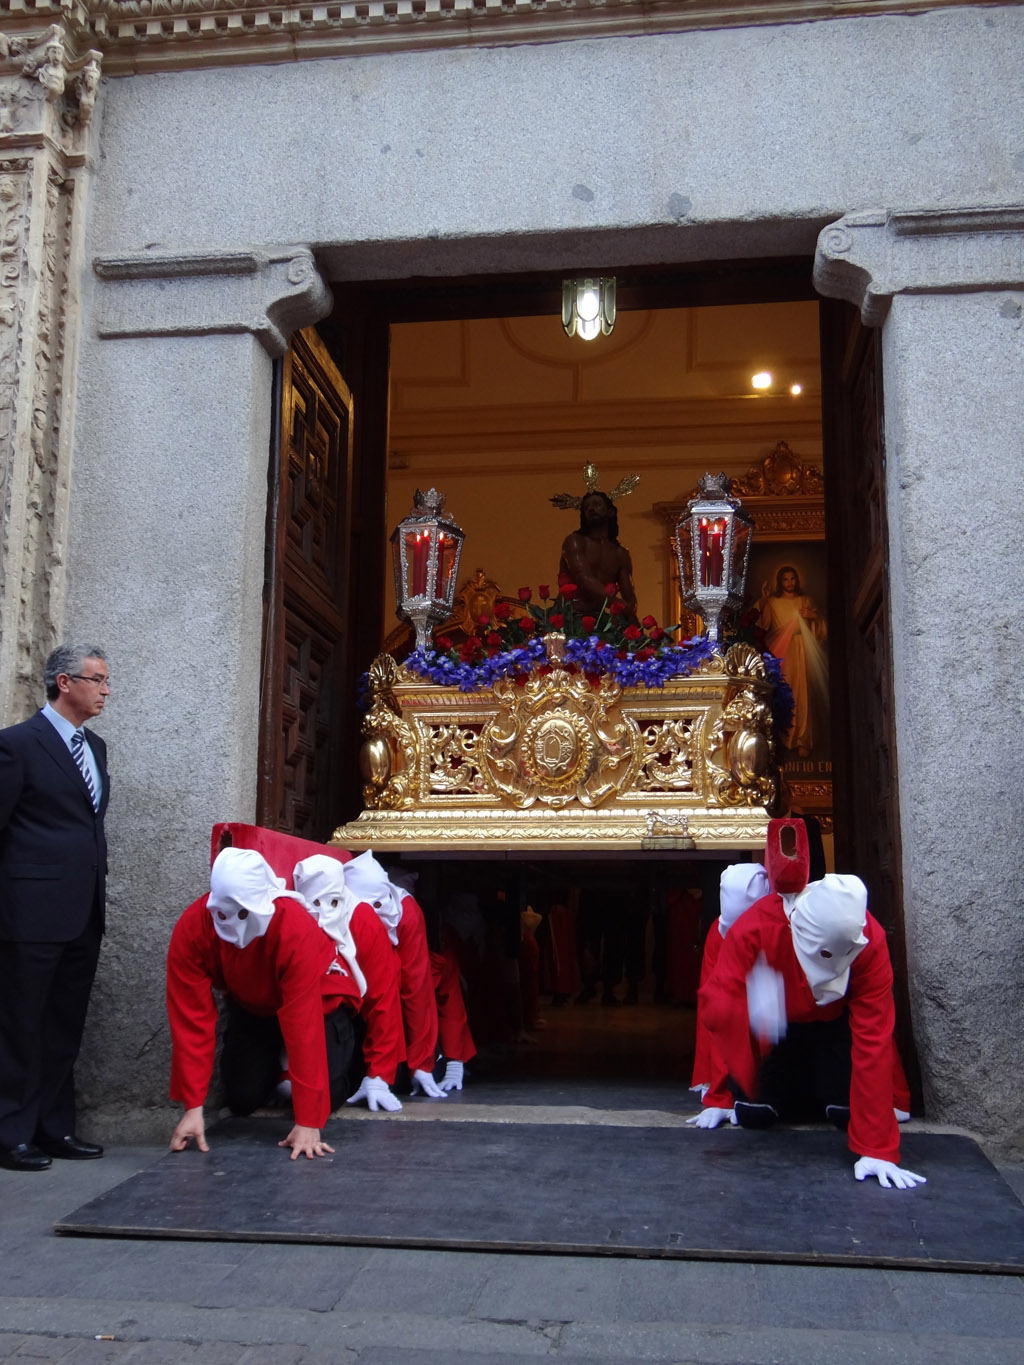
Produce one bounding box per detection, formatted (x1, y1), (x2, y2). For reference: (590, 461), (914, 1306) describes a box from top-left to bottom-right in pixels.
(93, 246), (332, 356)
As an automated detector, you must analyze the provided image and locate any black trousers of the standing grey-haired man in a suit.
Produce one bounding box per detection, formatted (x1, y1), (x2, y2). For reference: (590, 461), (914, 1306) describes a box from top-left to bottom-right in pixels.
(0, 910), (102, 1147)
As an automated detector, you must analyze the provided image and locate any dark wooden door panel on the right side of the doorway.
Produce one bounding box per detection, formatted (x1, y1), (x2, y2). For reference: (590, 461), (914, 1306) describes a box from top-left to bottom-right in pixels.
(822, 300), (919, 1093)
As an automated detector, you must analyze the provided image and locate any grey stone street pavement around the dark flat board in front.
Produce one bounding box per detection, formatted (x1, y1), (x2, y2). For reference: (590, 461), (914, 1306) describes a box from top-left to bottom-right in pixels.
(0, 1145), (1024, 1365)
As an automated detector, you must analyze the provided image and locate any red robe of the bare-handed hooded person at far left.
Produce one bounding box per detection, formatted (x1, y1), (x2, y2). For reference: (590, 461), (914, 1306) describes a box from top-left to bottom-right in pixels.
(167, 895), (349, 1127)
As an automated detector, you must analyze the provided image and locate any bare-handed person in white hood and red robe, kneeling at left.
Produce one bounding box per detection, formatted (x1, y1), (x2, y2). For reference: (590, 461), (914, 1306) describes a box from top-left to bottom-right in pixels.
(167, 848), (359, 1160)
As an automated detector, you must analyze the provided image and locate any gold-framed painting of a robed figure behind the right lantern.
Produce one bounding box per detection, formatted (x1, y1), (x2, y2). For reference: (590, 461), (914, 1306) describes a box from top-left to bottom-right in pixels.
(655, 441), (831, 831)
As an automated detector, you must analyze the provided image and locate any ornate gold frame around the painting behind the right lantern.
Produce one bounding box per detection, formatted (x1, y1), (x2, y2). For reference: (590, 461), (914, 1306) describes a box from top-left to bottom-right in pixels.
(654, 441), (833, 833)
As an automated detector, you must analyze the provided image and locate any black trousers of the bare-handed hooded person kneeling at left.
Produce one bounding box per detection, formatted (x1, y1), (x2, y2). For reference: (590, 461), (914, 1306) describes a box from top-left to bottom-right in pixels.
(220, 1001), (365, 1115)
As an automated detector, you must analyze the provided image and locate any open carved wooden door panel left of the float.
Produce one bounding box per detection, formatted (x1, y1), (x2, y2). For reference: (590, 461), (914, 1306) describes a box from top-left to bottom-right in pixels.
(257, 328), (352, 841)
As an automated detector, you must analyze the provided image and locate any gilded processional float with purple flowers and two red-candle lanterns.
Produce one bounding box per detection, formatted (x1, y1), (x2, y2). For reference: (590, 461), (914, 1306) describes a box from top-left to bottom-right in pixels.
(333, 465), (788, 854)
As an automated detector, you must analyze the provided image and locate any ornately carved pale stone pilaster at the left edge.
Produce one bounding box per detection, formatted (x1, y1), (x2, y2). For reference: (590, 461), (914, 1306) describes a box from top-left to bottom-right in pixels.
(0, 10), (101, 725)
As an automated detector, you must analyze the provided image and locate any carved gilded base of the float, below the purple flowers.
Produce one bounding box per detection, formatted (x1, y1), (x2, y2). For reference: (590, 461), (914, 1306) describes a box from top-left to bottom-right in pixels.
(341, 635), (780, 850)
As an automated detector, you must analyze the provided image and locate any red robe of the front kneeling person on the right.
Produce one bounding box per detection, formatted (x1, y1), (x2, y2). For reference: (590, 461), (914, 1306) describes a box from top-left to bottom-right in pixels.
(700, 893), (900, 1162)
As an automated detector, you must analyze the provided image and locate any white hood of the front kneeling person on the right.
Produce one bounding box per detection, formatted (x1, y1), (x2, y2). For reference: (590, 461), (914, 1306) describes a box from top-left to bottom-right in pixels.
(789, 872), (868, 1005)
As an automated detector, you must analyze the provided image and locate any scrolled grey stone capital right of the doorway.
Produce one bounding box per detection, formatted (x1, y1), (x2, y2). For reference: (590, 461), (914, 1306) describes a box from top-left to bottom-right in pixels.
(814, 205), (1024, 328)
